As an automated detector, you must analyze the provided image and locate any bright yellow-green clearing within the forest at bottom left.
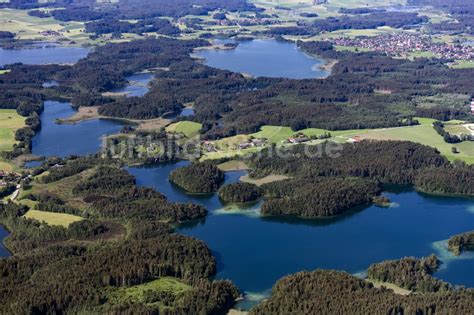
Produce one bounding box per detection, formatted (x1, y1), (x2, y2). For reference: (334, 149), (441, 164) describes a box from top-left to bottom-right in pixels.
(108, 277), (193, 308)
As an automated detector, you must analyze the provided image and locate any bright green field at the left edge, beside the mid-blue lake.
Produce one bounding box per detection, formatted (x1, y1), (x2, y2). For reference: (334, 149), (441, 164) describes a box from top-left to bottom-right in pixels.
(0, 109), (25, 151)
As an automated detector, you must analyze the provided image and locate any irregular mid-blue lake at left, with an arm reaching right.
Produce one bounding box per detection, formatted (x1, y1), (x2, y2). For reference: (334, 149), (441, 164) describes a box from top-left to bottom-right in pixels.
(32, 101), (122, 157)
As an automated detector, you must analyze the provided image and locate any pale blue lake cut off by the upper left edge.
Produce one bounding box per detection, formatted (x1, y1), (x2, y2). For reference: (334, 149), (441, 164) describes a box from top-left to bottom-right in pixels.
(0, 46), (89, 66)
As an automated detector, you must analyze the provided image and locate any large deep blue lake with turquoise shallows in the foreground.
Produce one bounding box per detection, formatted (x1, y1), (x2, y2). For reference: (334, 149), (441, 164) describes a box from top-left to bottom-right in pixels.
(128, 162), (474, 305)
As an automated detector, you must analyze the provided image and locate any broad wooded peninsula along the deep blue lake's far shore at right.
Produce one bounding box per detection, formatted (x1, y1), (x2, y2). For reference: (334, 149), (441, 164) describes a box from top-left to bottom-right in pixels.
(243, 141), (472, 218)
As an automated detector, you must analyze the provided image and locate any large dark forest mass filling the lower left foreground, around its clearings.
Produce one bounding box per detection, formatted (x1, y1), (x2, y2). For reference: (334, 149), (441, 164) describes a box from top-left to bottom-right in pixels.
(0, 156), (244, 314)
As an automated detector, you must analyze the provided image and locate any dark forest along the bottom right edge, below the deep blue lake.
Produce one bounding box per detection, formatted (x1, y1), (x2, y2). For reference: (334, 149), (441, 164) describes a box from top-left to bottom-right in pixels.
(250, 270), (474, 315)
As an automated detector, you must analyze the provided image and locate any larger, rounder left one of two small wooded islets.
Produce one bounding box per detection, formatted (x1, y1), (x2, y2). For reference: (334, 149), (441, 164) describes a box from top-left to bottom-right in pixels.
(169, 162), (224, 193)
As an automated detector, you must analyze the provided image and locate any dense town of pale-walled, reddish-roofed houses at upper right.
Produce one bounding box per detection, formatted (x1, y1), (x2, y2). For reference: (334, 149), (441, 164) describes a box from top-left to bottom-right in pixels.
(332, 32), (474, 60)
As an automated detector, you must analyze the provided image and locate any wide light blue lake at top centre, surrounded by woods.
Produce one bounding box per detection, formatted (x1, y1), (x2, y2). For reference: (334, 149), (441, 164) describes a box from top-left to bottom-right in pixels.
(195, 39), (328, 79)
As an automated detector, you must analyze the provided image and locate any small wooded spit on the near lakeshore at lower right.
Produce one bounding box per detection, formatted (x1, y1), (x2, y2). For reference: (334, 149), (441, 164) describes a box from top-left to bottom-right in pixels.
(367, 255), (451, 293)
